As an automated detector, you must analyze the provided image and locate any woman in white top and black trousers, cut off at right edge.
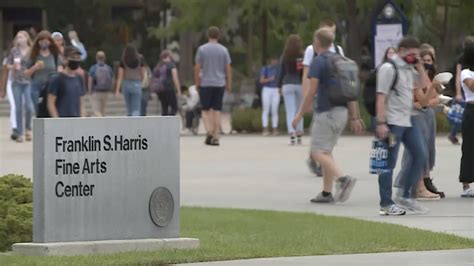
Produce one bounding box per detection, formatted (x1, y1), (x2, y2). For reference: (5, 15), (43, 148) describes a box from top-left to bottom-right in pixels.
(459, 36), (474, 198)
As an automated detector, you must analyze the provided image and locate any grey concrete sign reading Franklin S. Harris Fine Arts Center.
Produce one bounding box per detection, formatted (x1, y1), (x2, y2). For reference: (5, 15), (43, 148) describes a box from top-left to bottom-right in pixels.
(13, 117), (199, 255)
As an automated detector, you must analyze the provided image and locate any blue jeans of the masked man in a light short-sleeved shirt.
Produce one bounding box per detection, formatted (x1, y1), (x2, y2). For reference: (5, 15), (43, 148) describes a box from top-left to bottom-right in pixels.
(379, 122), (428, 207)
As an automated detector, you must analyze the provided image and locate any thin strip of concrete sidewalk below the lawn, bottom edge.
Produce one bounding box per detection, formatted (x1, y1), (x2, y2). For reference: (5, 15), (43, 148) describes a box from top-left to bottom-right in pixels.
(182, 249), (474, 266)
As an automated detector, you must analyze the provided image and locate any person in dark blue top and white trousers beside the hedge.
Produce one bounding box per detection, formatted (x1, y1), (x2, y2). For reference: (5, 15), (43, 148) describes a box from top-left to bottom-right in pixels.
(260, 55), (280, 136)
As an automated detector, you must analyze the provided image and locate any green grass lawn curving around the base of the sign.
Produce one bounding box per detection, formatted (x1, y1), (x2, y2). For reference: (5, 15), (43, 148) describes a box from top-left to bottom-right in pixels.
(0, 207), (474, 265)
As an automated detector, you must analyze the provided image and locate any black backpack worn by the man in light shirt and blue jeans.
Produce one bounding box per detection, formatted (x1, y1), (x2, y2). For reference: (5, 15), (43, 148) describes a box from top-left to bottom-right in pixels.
(362, 59), (398, 117)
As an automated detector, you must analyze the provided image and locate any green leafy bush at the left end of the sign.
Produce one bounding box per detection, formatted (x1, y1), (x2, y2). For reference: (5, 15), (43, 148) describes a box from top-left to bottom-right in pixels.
(0, 175), (33, 251)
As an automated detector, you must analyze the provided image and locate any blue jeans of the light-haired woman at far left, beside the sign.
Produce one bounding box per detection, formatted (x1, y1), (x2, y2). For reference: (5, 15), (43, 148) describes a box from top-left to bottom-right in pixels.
(12, 82), (33, 136)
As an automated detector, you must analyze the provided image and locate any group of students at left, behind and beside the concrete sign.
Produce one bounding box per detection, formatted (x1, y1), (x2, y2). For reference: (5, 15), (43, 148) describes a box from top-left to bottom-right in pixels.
(0, 30), (204, 142)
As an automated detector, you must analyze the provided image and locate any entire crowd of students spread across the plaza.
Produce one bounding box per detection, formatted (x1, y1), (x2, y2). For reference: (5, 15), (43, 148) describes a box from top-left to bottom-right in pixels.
(0, 20), (474, 215)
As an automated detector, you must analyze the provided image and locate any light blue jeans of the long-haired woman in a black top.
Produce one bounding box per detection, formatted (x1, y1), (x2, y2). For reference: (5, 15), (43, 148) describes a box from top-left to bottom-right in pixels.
(283, 84), (303, 135)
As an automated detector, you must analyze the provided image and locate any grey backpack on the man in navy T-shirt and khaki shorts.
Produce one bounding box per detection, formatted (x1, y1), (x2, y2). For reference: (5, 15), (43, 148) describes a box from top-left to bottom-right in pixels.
(324, 53), (360, 106)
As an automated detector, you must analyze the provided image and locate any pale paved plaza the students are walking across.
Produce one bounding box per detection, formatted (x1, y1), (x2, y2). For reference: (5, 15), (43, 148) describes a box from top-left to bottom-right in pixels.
(0, 118), (474, 265)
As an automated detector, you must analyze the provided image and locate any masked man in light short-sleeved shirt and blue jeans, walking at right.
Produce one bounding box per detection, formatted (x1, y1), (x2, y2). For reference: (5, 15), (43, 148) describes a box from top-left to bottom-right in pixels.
(375, 37), (435, 215)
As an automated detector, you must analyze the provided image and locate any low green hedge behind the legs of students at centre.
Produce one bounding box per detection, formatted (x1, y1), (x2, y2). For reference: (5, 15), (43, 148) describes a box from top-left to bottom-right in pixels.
(231, 107), (312, 133)
